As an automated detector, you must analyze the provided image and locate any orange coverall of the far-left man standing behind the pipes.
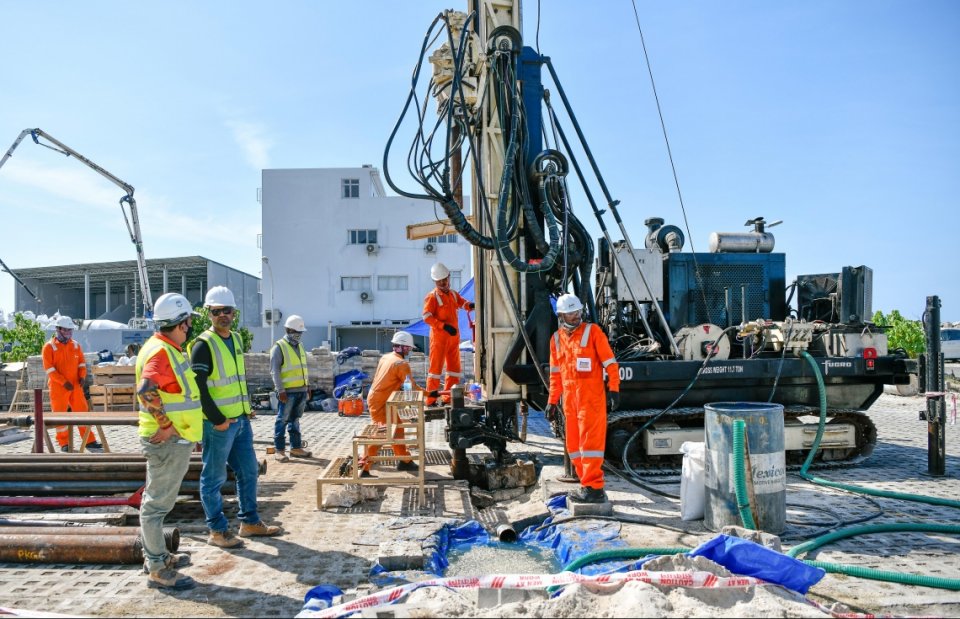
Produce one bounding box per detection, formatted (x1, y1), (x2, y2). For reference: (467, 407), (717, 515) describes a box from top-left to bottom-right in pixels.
(41, 335), (96, 447)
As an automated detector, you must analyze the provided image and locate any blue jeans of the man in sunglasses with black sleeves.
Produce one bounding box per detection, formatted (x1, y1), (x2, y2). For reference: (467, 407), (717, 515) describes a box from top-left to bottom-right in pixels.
(200, 415), (260, 531)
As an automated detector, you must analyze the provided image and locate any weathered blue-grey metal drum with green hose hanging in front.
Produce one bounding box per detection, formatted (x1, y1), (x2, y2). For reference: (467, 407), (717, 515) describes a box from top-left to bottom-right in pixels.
(704, 402), (787, 535)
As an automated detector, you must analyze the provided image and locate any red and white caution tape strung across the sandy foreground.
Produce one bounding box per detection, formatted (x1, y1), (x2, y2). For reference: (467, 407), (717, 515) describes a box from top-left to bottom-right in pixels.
(297, 570), (873, 619)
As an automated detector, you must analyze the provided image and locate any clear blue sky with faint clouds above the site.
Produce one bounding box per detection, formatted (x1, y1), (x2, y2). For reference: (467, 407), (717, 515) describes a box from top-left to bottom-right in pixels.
(0, 0), (960, 321)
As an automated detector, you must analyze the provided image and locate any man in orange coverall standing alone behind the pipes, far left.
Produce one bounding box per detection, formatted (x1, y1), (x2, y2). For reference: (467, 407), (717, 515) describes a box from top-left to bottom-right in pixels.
(41, 316), (103, 451)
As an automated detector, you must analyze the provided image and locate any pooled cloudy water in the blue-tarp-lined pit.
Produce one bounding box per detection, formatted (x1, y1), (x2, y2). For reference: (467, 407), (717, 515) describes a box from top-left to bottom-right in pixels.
(443, 542), (562, 576)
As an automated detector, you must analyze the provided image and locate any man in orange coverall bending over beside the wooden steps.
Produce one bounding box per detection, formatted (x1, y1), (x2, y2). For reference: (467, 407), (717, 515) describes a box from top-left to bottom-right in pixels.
(360, 331), (438, 477)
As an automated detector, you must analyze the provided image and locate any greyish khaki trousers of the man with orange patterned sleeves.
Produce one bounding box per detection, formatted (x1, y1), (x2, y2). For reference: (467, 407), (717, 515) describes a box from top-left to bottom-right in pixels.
(140, 436), (195, 572)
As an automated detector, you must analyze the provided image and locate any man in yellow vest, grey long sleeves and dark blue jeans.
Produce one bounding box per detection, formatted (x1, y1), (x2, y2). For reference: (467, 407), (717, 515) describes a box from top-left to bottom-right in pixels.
(270, 314), (311, 462)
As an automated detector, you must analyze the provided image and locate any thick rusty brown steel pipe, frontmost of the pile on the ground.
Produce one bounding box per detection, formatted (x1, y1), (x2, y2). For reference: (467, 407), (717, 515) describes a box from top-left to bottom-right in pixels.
(0, 535), (143, 565)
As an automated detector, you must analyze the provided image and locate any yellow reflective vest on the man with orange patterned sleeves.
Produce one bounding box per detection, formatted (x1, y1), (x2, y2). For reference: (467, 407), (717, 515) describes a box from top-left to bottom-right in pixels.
(137, 336), (203, 443)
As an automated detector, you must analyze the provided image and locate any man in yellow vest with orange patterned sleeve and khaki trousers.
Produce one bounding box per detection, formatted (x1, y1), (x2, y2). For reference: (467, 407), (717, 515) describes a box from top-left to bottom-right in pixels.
(136, 292), (203, 590)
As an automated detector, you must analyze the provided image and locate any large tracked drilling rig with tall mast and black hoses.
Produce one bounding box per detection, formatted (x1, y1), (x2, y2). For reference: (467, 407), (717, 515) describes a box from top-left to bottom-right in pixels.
(383, 0), (917, 478)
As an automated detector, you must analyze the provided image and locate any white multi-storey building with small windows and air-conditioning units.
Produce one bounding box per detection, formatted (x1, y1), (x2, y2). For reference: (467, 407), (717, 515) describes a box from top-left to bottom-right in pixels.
(255, 165), (471, 350)
